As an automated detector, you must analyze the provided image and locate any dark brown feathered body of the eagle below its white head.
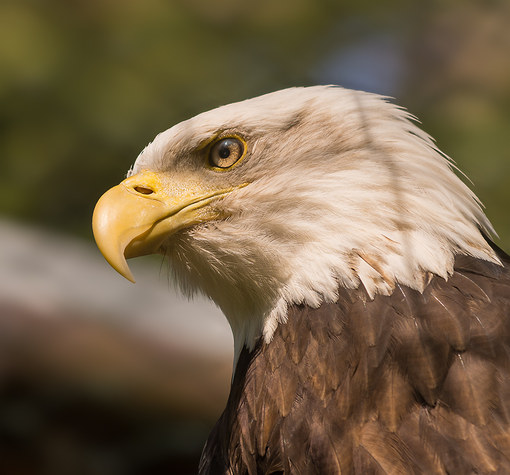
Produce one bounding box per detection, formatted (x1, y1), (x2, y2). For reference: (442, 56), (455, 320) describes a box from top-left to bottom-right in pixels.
(200, 250), (510, 475)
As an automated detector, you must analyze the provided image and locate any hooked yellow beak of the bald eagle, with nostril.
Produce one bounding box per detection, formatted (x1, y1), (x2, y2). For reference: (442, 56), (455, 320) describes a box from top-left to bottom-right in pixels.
(92, 172), (237, 282)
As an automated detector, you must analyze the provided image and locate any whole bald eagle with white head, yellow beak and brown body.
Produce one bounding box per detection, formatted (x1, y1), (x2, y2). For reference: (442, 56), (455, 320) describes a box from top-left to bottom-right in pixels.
(93, 86), (510, 474)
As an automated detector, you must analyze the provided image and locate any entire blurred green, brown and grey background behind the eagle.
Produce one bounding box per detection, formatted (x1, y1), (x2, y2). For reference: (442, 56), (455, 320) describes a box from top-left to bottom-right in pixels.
(0, 0), (510, 475)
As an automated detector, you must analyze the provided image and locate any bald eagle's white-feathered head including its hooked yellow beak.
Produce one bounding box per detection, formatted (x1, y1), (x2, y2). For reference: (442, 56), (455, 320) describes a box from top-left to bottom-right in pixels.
(93, 86), (498, 353)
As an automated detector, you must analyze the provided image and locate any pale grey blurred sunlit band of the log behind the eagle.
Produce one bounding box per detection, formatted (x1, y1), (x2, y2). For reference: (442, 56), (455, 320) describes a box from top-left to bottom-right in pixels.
(0, 221), (233, 358)
